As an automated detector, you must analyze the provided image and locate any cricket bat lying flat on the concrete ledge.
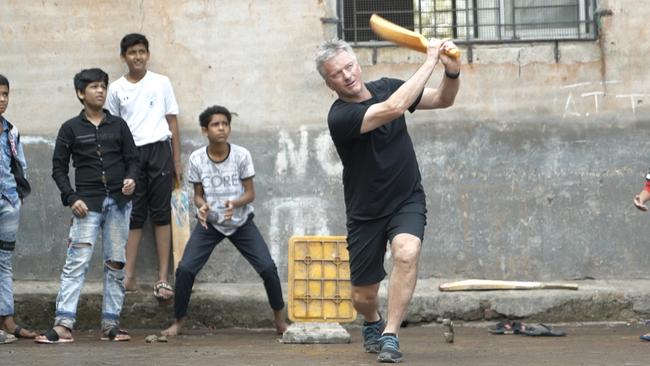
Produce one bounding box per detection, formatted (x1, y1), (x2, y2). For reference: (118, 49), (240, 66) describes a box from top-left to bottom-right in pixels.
(438, 280), (578, 292)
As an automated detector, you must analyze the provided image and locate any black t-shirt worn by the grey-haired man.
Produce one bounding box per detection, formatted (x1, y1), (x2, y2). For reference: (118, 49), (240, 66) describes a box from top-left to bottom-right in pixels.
(327, 78), (422, 220)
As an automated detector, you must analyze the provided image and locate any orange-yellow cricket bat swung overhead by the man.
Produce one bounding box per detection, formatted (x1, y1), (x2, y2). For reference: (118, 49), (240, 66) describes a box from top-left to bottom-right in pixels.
(370, 14), (460, 59)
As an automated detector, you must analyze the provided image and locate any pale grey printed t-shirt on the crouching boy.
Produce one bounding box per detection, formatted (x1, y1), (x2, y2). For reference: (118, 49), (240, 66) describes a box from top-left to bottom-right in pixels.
(187, 144), (255, 235)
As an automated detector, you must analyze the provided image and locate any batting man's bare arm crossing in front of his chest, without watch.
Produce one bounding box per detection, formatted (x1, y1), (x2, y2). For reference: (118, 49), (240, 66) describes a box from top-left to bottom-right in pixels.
(361, 40), (455, 133)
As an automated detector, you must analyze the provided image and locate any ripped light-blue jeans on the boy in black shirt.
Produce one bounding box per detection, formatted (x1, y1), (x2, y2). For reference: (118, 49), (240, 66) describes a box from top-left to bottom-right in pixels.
(54, 197), (131, 329)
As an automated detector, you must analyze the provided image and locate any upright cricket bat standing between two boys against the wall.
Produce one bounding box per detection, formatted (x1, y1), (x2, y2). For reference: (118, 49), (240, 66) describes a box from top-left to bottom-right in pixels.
(171, 181), (190, 273)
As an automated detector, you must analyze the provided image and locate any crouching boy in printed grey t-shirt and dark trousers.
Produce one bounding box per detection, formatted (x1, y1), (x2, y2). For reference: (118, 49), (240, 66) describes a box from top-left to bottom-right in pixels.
(162, 106), (287, 336)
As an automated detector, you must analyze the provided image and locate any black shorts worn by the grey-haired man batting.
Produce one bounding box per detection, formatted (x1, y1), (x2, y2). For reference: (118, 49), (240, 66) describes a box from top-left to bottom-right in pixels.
(347, 190), (427, 286)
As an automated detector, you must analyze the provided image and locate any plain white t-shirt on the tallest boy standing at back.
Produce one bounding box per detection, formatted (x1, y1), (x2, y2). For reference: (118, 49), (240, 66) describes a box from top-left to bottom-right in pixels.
(106, 70), (178, 146)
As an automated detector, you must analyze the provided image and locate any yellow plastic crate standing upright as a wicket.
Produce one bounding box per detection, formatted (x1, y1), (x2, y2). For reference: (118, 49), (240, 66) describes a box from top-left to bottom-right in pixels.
(288, 236), (357, 323)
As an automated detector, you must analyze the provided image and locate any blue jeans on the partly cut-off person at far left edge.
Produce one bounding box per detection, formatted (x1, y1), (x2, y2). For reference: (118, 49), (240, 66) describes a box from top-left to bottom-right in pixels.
(0, 196), (20, 316)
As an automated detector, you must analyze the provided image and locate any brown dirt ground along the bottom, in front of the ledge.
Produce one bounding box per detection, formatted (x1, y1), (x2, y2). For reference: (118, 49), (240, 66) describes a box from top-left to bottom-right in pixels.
(0, 323), (650, 366)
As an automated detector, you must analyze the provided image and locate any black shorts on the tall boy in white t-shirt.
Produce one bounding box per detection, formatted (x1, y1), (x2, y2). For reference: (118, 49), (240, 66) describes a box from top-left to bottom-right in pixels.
(129, 141), (174, 229)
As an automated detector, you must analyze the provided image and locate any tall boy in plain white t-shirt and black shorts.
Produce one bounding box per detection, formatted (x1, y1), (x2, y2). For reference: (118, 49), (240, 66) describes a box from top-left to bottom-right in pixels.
(106, 33), (183, 301)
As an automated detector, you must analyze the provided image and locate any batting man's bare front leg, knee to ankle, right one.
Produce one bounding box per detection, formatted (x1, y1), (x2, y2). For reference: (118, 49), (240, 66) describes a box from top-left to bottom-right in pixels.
(384, 234), (421, 335)
